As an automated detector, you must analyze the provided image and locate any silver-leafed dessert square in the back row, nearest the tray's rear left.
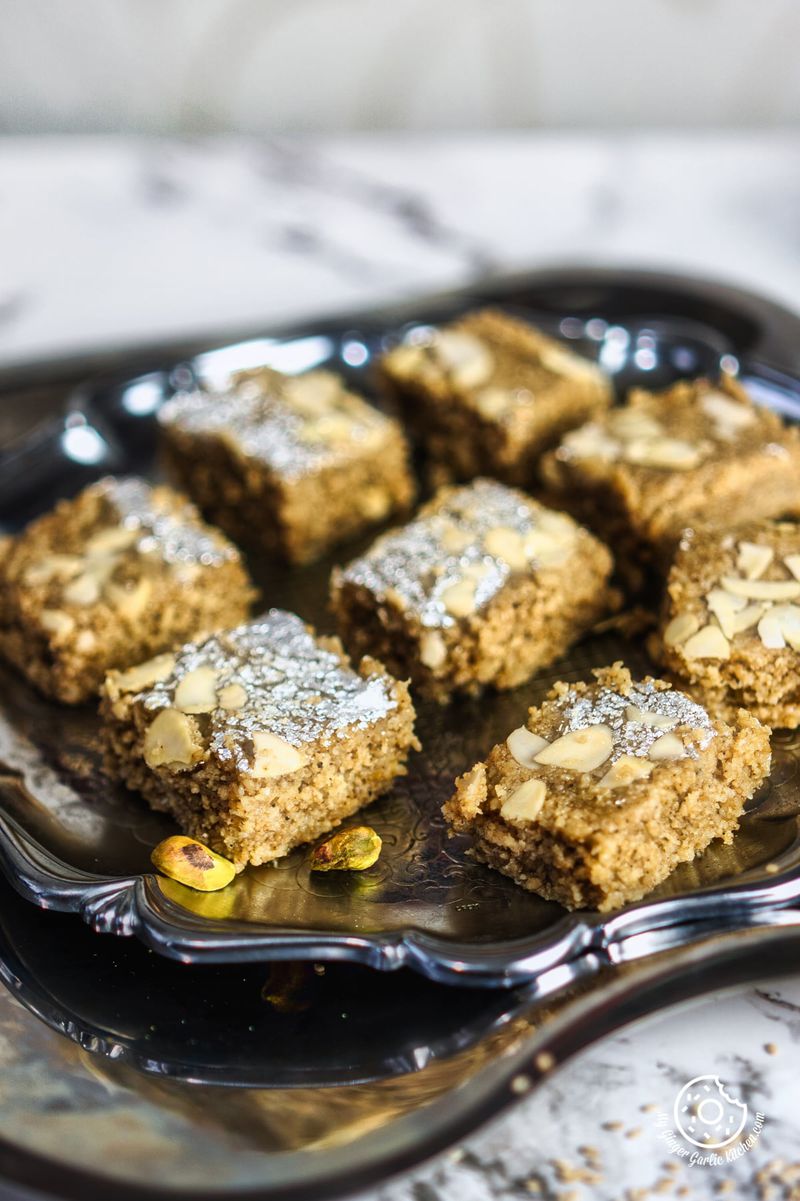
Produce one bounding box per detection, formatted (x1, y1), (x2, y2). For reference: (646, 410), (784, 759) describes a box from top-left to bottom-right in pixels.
(159, 370), (414, 563)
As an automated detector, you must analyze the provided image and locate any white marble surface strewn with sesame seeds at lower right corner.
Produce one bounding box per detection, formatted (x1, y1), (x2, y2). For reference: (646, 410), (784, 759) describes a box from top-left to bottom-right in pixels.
(377, 975), (800, 1201)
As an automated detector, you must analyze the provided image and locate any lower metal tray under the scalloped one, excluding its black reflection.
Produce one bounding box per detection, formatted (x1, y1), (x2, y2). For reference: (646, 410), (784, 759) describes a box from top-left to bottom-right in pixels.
(0, 898), (800, 1201)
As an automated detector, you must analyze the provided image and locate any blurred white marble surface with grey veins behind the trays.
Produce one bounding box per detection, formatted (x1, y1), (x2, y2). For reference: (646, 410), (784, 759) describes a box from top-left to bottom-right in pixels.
(0, 132), (800, 364)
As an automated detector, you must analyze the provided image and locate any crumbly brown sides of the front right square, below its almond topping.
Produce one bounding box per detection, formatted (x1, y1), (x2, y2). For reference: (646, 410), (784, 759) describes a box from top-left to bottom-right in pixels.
(443, 664), (770, 912)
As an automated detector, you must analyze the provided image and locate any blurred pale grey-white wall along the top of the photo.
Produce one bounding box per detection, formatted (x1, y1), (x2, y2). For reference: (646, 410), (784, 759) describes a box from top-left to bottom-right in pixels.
(0, 0), (800, 135)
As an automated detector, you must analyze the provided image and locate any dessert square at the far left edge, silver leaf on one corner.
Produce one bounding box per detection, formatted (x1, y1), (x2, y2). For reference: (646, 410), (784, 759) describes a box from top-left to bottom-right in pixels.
(0, 478), (255, 704)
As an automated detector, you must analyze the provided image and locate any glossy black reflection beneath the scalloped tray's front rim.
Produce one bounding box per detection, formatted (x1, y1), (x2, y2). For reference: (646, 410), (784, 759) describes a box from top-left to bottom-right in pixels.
(0, 879), (526, 1089)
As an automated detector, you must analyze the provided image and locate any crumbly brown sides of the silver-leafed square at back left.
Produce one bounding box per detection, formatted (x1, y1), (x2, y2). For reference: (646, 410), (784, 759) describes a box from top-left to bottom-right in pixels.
(162, 379), (416, 563)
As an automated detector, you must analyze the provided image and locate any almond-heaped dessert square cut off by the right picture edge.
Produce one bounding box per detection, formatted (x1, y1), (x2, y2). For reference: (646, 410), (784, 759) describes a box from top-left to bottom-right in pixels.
(650, 521), (800, 729)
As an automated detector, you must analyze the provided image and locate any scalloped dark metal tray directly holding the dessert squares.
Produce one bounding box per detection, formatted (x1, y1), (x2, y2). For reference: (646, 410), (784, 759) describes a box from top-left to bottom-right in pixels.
(0, 271), (800, 996)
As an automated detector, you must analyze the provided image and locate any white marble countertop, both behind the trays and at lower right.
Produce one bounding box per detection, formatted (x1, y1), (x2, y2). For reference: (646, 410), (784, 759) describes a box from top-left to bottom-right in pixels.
(0, 133), (800, 1201)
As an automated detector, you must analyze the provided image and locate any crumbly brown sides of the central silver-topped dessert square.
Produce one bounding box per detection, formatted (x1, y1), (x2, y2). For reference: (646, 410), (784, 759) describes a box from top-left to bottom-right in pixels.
(332, 489), (619, 704)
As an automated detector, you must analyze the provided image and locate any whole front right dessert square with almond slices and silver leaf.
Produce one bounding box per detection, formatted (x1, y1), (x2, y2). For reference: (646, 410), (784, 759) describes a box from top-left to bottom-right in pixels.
(443, 663), (770, 912)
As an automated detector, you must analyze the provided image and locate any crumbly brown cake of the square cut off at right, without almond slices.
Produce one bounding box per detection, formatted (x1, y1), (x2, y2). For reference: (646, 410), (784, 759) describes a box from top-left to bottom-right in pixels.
(649, 521), (800, 730)
